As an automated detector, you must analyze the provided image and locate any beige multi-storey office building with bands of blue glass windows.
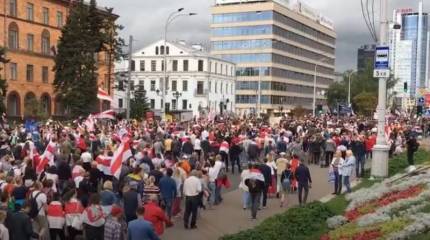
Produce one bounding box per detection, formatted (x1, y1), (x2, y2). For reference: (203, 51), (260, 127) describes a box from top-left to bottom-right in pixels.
(211, 0), (336, 114)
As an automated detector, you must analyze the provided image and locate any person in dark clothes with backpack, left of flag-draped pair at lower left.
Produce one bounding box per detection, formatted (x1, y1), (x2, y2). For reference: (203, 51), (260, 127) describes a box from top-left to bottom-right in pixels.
(28, 181), (49, 238)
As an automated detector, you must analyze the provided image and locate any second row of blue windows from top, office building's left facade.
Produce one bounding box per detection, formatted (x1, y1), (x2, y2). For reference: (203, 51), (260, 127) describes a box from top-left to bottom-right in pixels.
(212, 25), (273, 37)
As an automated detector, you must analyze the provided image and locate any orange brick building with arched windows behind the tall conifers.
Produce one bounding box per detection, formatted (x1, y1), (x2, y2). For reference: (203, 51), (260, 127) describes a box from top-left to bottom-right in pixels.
(0, 0), (118, 117)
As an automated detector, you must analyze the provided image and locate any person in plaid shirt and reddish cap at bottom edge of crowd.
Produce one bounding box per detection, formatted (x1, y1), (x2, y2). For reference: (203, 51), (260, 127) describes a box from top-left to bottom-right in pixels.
(104, 205), (127, 240)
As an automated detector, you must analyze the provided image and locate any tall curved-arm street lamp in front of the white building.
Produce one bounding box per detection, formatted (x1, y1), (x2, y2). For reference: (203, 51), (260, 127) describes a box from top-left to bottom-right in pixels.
(161, 8), (197, 119)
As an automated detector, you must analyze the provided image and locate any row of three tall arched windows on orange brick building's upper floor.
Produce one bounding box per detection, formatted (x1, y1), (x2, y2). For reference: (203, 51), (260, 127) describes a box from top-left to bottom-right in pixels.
(8, 22), (51, 55)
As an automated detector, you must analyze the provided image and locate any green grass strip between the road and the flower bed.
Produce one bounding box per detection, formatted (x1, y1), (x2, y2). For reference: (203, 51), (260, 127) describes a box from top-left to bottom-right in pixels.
(221, 150), (430, 240)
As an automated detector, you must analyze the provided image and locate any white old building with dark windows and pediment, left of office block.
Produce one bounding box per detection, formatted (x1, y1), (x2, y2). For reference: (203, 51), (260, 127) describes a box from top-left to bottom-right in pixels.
(114, 40), (236, 116)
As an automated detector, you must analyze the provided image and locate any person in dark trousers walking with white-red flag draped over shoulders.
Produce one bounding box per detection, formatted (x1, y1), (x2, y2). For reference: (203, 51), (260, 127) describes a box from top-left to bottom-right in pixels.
(245, 164), (265, 220)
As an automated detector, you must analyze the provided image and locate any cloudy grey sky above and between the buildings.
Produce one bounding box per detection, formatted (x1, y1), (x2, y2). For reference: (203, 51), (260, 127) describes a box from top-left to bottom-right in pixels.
(98, 0), (430, 72)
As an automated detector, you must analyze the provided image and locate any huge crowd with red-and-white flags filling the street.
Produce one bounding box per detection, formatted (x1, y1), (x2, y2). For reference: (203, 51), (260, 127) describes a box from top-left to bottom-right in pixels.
(0, 113), (418, 240)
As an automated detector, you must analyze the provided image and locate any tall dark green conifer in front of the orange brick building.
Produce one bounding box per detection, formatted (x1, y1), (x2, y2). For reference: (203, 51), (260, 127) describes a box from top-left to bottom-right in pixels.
(54, 0), (121, 117)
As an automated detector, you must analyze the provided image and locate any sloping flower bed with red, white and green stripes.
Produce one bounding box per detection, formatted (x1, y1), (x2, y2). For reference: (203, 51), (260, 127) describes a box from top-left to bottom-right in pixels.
(320, 171), (430, 240)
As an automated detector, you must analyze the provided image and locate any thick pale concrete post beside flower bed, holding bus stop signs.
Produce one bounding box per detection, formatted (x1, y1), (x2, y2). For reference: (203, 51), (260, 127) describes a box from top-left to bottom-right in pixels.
(371, 0), (389, 177)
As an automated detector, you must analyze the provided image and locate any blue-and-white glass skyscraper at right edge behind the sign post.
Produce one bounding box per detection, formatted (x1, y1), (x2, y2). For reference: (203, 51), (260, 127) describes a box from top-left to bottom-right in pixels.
(390, 2), (430, 100)
